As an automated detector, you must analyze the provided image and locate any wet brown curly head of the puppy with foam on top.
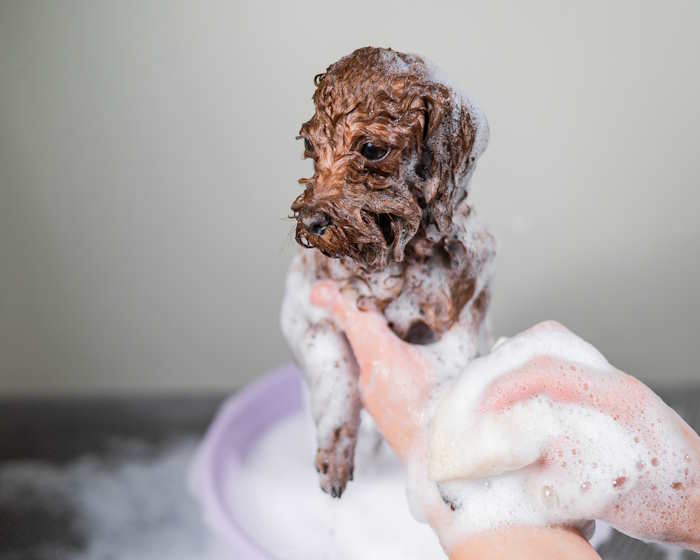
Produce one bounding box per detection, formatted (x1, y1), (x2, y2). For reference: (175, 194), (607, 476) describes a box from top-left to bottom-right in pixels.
(292, 47), (488, 269)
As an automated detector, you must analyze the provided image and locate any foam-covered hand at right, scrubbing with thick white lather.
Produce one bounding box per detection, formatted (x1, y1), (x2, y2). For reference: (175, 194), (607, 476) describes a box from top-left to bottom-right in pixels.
(416, 322), (700, 549)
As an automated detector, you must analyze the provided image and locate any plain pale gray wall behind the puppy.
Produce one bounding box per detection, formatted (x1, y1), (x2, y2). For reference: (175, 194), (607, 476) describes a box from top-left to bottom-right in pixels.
(0, 0), (700, 394)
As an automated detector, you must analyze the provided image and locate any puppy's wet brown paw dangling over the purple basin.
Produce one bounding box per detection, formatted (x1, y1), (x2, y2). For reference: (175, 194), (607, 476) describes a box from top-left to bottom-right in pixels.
(316, 427), (357, 498)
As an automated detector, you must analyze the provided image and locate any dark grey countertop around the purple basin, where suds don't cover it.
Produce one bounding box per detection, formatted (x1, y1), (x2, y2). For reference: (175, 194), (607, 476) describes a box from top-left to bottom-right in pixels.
(0, 386), (700, 560)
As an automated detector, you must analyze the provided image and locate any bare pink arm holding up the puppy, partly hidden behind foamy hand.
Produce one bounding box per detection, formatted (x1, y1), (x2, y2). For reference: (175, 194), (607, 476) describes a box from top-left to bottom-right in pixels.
(311, 282), (600, 560)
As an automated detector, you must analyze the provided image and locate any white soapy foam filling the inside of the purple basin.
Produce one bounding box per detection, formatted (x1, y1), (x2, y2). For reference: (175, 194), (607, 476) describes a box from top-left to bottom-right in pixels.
(227, 406), (444, 560)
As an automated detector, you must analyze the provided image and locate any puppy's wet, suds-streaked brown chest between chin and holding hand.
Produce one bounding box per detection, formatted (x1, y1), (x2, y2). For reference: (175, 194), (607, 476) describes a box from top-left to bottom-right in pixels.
(314, 249), (476, 344)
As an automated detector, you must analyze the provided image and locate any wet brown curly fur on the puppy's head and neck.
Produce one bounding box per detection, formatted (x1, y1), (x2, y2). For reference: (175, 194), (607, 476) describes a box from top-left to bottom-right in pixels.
(292, 47), (488, 342)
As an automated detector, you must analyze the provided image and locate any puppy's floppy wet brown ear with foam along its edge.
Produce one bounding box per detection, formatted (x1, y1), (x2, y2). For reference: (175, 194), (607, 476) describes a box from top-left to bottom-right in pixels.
(416, 83), (488, 232)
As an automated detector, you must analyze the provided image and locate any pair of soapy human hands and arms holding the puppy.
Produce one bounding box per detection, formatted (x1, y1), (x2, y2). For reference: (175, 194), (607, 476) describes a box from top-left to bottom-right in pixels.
(311, 282), (700, 559)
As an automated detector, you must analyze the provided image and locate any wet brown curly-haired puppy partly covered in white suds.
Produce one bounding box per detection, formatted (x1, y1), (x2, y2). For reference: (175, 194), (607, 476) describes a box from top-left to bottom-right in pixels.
(281, 47), (495, 497)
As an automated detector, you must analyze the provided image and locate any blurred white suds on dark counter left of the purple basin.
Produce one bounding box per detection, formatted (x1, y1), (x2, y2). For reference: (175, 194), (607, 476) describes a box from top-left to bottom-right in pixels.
(0, 438), (231, 560)
